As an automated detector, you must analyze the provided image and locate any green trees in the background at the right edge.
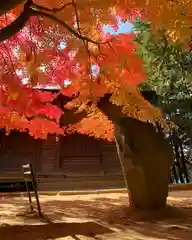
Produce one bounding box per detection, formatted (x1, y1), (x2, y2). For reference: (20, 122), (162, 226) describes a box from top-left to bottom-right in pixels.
(134, 19), (192, 182)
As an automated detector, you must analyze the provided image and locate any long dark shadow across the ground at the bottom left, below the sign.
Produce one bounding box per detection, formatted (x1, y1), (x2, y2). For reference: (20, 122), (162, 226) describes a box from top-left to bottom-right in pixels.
(0, 222), (113, 240)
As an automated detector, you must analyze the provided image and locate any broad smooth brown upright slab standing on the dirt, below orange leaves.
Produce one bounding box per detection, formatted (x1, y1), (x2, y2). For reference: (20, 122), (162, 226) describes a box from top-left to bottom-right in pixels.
(115, 118), (173, 209)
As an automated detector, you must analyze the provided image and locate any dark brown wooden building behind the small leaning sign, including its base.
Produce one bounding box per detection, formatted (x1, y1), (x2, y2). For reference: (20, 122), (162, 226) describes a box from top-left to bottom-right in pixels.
(0, 132), (124, 191)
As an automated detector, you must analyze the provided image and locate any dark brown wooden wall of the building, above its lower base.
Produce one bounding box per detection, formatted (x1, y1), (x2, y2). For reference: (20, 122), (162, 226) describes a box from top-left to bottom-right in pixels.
(0, 132), (122, 176)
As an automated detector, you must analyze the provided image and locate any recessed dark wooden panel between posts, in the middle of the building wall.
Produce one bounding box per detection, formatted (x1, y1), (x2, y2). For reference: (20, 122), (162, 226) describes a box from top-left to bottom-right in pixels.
(59, 134), (102, 175)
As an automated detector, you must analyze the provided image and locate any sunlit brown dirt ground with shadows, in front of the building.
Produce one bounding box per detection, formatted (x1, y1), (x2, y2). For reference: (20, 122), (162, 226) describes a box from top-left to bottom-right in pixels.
(0, 191), (192, 240)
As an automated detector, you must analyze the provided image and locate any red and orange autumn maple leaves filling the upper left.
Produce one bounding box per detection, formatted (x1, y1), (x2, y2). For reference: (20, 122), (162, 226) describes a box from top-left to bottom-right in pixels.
(0, 0), (181, 139)
